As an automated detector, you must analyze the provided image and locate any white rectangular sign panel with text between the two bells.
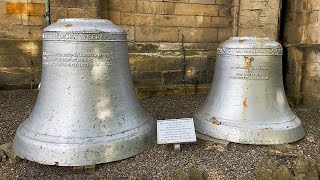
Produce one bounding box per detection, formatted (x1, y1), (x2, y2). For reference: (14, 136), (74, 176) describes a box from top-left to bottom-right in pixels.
(157, 118), (197, 144)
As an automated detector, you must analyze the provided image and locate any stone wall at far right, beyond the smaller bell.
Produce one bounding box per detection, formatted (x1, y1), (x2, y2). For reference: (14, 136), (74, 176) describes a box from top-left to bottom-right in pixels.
(284, 0), (320, 106)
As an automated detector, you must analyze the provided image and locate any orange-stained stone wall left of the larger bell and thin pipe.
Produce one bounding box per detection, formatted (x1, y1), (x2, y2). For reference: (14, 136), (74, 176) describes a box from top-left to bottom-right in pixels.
(0, 0), (45, 88)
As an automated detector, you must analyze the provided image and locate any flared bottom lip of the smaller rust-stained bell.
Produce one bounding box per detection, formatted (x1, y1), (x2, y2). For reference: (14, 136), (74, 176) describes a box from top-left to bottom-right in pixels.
(194, 115), (305, 145)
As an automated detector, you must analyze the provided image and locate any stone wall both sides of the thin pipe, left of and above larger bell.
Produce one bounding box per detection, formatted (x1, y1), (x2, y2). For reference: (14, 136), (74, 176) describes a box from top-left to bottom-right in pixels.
(0, 0), (108, 89)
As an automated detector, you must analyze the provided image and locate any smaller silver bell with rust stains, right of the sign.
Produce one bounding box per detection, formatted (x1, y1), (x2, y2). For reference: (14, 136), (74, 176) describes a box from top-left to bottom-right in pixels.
(194, 37), (304, 144)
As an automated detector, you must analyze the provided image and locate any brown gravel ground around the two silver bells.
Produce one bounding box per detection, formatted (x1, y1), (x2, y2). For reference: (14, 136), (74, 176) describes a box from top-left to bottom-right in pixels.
(0, 90), (320, 180)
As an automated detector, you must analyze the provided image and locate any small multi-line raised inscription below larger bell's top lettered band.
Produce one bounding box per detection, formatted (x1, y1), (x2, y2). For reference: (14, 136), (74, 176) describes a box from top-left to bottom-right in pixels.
(43, 52), (114, 67)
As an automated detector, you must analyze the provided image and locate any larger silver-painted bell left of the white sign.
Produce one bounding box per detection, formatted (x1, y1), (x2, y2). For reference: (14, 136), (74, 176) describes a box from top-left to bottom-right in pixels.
(13, 19), (156, 166)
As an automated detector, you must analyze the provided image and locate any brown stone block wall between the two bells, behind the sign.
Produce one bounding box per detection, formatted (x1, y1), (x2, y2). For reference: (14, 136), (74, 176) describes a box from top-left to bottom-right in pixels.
(109, 0), (233, 97)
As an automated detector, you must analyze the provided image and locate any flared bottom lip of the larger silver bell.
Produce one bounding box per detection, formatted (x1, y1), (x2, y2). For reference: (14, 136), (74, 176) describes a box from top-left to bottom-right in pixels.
(13, 121), (156, 166)
